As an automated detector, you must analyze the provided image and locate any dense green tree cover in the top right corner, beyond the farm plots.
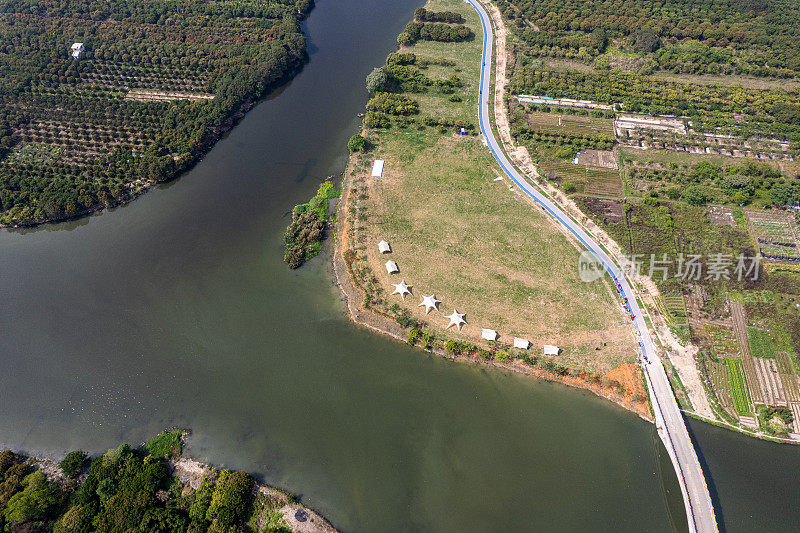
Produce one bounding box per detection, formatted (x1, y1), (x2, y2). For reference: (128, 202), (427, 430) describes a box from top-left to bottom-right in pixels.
(497, 0), (800, 78)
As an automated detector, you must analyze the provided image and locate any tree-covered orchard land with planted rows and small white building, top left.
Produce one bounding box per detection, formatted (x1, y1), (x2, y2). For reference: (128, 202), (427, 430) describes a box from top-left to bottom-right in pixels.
(0, 0), (313, 224)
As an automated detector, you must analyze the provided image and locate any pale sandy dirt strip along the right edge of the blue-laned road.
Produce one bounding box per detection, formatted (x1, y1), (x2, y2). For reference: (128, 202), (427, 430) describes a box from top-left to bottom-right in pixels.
(481, 0), (716, 420)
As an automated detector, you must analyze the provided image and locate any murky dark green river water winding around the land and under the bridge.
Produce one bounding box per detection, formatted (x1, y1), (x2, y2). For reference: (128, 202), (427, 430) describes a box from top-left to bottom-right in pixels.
(0, 0), (800, 531)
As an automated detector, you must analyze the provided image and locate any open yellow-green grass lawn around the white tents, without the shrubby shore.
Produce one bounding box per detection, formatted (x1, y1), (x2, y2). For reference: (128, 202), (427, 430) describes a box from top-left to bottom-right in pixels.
(346, 0), (635, 381)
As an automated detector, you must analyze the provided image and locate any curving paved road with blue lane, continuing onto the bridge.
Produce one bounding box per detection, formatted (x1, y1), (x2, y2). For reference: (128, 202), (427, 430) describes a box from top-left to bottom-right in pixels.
(465, 0), (718, 533)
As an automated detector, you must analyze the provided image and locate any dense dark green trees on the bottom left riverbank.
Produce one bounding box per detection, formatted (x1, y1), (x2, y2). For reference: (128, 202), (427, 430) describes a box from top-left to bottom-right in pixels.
(0, 431), (310, 533)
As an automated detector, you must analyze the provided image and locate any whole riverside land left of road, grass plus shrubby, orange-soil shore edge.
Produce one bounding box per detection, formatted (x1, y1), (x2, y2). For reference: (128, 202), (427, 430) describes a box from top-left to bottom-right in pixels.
(333, 0), (650, 418)
